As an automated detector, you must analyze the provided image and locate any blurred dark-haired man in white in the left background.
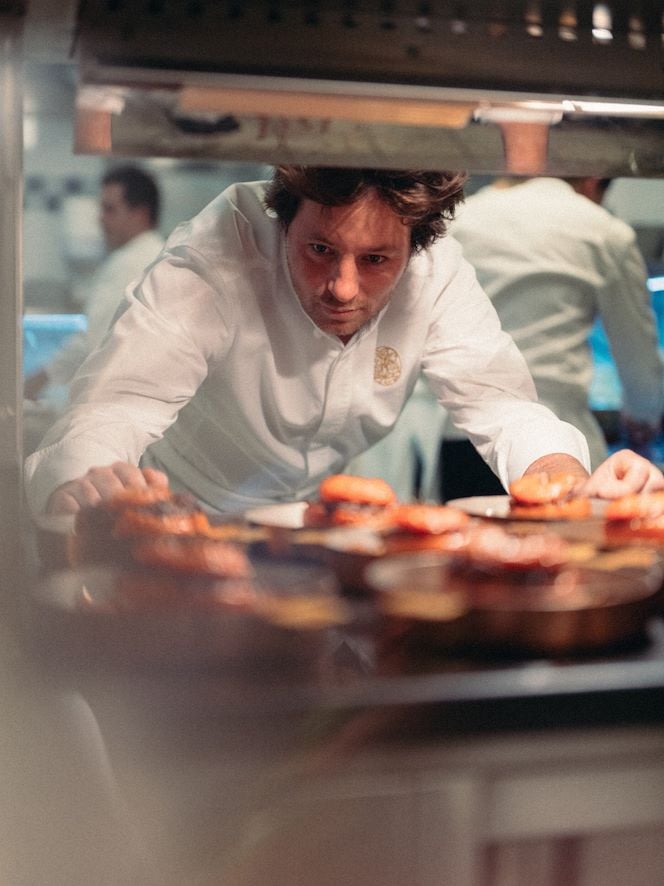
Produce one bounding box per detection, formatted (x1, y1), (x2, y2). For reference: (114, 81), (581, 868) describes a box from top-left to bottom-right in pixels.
(24, 165), (164, 400)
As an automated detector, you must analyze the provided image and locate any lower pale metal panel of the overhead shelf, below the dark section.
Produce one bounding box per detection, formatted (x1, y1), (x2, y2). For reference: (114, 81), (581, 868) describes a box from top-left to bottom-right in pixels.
(72, 75), (664, 177)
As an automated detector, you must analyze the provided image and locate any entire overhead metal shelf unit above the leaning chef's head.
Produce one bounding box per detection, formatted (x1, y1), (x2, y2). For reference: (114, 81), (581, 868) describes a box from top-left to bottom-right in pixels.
(65, 0), (664, 177)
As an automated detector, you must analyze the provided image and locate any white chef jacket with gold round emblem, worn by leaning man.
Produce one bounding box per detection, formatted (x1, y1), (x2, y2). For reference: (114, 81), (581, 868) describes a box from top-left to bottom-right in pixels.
(26, 182), (588, 513)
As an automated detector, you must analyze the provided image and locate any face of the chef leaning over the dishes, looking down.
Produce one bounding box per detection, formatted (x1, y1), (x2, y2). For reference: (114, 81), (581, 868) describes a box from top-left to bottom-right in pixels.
(286, 193), (410, 342)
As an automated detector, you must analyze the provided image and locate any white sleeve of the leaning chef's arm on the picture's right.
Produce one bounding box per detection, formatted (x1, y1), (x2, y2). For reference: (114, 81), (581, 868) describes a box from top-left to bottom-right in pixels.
(422, 262), (590, 487)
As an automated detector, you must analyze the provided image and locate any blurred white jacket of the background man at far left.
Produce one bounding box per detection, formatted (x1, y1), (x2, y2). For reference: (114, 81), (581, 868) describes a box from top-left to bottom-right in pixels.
(44, 229), (164, 384)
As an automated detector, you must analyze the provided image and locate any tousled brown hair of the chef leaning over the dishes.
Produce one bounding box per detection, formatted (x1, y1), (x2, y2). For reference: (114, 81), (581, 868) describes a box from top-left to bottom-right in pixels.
(265, 166), (467, 252)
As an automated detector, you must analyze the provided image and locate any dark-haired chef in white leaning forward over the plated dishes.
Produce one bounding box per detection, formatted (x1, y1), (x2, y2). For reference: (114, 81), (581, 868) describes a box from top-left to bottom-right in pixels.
(26, 166), (664, 514)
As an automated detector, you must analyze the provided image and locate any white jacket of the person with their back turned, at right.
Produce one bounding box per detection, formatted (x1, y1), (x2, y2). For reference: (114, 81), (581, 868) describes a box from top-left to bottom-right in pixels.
(446, 178), (664, 468)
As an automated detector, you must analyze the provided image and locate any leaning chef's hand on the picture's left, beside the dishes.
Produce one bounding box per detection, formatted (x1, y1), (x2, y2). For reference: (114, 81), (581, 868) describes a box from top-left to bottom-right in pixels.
(46, 461), (168, 514)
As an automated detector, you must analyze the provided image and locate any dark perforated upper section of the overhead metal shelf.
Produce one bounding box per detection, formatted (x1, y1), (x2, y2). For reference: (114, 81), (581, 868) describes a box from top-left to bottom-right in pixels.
(78, 0), (662, 100)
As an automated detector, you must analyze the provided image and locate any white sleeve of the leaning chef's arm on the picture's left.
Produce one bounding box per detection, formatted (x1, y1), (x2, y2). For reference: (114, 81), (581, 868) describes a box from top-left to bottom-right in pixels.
(25, 261), (230, 514)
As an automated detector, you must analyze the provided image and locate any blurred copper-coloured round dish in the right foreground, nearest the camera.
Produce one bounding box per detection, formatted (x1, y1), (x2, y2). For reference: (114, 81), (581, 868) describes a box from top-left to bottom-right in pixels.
(365, 554), (662, 655)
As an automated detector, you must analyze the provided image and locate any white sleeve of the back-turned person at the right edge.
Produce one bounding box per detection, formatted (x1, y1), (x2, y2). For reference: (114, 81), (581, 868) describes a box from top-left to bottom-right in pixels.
(598, 229), (664, 425)
